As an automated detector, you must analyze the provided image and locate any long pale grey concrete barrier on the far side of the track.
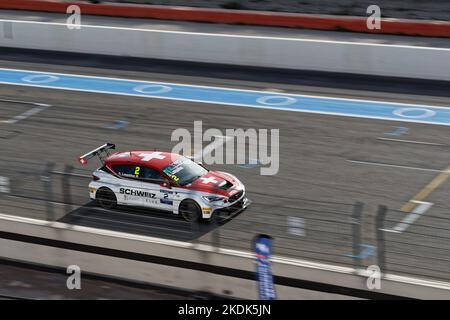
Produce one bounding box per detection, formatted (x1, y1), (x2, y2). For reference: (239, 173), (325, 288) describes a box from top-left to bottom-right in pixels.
(0, 20), (450, 81)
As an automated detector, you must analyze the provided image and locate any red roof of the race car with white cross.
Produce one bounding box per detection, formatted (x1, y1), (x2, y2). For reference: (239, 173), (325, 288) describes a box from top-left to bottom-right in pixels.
(105, 150), (182, 169)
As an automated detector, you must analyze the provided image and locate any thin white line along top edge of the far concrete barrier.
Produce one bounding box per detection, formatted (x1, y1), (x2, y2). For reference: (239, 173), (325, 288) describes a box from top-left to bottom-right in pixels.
(0, 19), (450, 51)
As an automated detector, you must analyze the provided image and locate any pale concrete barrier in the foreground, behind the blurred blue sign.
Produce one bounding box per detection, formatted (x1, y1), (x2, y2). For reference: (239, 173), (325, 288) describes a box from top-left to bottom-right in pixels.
(0, 214), (450, 299)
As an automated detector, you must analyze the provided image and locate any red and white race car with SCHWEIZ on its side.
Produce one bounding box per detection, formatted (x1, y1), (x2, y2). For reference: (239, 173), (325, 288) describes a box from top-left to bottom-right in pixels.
(79, 143), (250, 222)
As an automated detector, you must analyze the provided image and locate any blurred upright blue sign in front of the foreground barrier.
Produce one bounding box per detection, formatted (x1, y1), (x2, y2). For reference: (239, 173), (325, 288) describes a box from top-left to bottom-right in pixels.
(254, 235), (276, 300)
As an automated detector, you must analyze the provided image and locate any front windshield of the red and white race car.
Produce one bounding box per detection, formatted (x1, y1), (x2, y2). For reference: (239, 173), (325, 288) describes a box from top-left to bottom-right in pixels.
(163, 157), (208, 186)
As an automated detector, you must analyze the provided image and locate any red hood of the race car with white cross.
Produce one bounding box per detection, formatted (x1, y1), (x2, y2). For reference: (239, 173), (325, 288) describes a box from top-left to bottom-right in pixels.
(185, 170), (243, 197)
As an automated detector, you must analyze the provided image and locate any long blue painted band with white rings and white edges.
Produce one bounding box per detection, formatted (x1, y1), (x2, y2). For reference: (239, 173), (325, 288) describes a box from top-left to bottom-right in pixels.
(0, 69), (450, 125)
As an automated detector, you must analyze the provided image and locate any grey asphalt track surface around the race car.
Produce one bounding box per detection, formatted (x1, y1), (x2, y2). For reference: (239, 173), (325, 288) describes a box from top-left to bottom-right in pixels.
(0, 11), (450, 281)
